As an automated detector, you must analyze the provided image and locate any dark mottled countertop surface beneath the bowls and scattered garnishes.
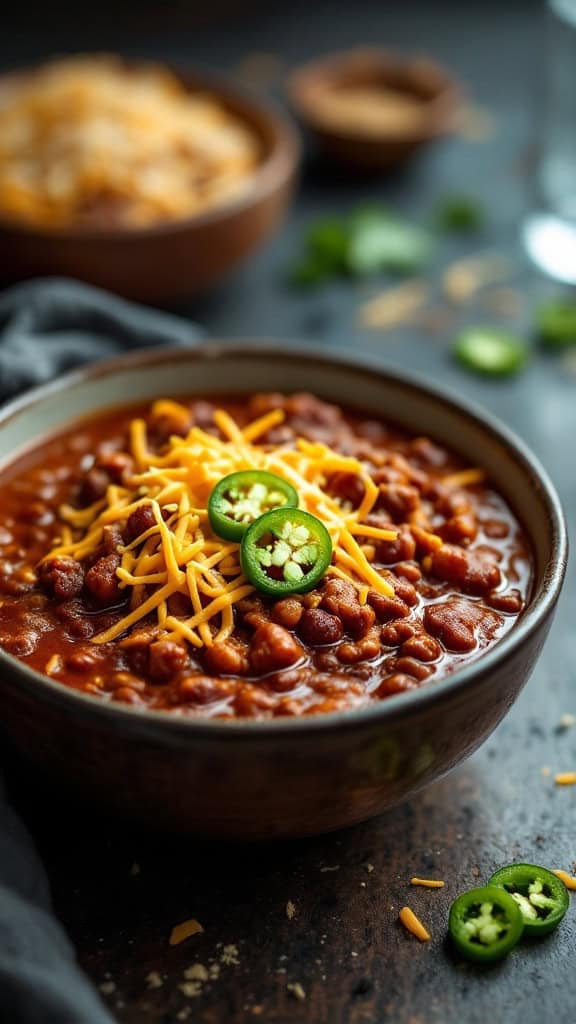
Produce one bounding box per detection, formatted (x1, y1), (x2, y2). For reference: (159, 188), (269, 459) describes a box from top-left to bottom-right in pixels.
(5, 0), (576, 1024)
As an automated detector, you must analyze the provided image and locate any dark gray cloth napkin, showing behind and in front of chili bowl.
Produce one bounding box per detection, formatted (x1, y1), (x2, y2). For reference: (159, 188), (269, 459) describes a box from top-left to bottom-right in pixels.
(0, 279), (201, 1024)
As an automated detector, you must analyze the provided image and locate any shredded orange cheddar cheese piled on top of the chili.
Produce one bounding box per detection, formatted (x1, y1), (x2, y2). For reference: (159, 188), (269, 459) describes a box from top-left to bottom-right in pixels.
(47, 399), (397, 647)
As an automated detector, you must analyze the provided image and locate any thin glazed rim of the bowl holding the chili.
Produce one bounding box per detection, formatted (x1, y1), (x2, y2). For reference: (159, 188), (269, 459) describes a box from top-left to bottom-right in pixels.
(0, 339), (568, 740)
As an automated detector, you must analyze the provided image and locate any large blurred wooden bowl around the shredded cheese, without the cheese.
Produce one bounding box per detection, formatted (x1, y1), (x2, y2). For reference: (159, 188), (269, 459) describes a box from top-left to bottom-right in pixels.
(0, 69), (299, 303)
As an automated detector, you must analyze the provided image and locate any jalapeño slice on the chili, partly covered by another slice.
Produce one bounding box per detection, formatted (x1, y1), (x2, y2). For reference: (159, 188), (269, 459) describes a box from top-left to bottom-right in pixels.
(208, 469), (298, 541)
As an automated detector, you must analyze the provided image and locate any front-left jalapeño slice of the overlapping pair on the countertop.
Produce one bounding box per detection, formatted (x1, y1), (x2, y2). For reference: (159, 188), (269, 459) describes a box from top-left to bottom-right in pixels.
(448, 886), (524, 964)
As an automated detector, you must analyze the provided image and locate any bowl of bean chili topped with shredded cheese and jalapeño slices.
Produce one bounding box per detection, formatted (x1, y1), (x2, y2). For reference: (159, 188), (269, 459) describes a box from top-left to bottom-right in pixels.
(0, 342), (567, 835)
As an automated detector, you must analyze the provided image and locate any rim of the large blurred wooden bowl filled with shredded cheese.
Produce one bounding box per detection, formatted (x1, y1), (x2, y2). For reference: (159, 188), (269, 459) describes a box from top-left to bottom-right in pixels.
(0, 61), (302, 243)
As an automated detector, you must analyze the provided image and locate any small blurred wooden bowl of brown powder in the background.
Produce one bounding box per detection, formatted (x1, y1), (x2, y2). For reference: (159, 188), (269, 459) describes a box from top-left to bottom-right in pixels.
(287, 48), (461, 172)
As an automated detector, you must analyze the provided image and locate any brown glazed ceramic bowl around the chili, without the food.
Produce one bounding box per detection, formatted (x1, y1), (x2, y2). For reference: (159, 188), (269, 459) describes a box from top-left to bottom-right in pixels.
(0, 343), (567, 839)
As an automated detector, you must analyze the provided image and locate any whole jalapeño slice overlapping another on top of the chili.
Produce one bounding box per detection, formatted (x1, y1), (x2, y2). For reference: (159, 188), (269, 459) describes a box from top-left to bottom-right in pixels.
(240, 508), (332, 597)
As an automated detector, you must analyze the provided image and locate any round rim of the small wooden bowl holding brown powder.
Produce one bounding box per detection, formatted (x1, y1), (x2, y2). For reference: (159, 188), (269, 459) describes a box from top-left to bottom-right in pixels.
(286, 45), (462, 147)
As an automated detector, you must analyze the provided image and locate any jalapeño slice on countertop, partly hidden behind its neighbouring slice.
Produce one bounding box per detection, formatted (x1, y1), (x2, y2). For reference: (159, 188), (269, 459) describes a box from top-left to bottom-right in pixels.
(488, 864), (570, 936)
